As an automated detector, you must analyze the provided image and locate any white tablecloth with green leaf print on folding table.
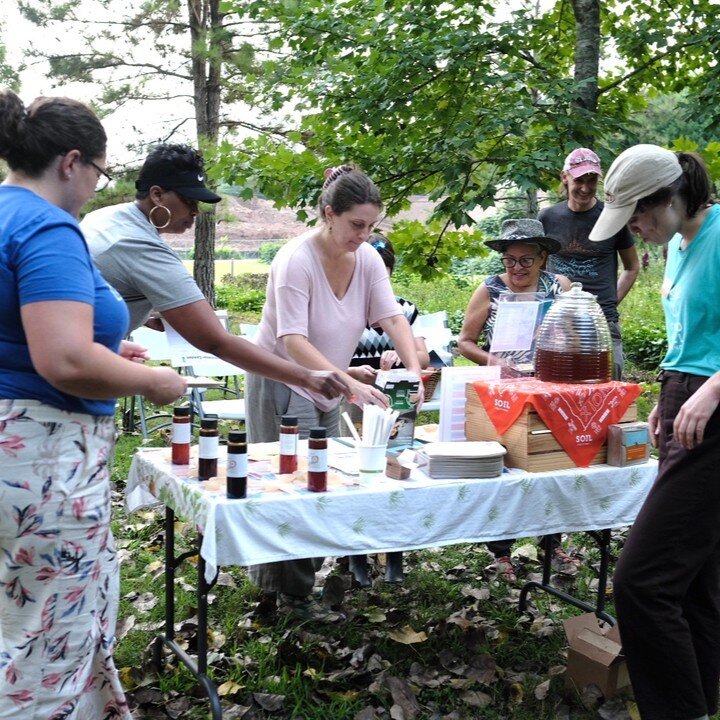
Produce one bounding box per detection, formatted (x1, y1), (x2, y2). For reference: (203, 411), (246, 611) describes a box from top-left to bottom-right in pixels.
(127, 442), (657, 581)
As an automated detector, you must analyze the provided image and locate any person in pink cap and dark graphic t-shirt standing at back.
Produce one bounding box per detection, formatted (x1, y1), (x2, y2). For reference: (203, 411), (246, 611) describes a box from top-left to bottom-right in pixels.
(538, 148), (640, 380)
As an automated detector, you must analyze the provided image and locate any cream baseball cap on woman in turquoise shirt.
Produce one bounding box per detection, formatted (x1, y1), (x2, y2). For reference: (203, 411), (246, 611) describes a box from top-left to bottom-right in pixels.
(590, 145), (682, 241)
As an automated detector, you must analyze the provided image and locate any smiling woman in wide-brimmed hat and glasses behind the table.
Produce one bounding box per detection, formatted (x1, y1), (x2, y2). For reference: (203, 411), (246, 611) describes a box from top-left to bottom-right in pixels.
(458, 218), (570, 581)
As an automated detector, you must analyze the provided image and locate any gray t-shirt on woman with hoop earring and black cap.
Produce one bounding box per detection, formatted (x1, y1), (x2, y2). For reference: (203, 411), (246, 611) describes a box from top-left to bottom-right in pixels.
(80, 203), (205, 331)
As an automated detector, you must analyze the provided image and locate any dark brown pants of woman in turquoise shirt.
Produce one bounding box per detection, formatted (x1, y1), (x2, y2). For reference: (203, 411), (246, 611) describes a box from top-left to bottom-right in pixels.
(615, 372), (720, 720)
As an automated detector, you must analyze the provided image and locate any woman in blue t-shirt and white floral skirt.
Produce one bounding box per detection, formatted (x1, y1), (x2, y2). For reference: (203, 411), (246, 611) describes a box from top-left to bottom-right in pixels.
(0, 91), (186, 720)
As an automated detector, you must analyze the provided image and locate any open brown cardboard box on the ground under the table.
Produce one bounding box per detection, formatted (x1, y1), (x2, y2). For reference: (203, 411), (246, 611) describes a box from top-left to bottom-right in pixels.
(563, 613), (630, 700)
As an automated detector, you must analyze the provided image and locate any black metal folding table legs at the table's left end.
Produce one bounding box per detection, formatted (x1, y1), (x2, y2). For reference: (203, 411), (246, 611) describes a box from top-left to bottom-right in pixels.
(153, 507), (222, 720)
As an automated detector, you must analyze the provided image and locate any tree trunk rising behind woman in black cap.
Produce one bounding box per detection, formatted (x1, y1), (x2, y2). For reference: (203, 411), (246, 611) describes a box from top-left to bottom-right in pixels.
(187, 0), (224, 307)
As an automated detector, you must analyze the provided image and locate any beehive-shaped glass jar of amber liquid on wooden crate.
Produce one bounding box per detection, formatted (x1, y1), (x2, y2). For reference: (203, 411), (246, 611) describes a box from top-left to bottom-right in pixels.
(535, 283), (613, 383)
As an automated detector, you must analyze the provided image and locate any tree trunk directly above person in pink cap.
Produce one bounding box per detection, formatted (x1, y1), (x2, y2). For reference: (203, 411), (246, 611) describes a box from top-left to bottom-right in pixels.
(572, 0), (600, 147)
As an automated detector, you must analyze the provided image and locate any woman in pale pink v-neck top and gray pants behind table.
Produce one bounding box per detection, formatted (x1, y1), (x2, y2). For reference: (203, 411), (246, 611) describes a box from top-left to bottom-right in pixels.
(245, 165), (422, 621)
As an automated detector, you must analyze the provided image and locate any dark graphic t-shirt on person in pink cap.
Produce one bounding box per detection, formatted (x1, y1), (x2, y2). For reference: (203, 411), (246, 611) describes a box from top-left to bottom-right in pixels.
(538, 200), (635, 322)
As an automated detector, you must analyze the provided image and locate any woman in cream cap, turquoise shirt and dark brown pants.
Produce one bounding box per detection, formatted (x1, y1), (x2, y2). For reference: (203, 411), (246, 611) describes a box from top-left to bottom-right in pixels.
(590, 145), (720, 720)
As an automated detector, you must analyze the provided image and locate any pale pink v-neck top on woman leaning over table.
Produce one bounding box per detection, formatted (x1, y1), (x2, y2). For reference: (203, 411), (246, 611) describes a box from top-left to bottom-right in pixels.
(253, 234), (402, 411)
